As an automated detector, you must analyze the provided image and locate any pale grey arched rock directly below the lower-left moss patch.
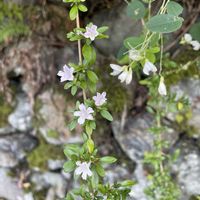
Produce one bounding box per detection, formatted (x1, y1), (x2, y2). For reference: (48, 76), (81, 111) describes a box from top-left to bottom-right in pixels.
(31, 172), (67, 198)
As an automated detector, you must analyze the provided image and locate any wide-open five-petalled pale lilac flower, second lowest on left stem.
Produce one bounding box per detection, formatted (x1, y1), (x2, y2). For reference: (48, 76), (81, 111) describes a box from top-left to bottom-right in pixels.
(74, 103), (94, 125)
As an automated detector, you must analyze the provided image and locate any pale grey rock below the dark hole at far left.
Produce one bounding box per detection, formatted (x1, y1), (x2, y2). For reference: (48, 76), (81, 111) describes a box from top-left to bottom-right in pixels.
(8, 93), (32, 132)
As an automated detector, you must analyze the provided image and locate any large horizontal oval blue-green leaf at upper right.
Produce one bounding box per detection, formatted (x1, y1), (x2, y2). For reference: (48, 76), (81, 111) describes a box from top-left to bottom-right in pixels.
(146, 14), (183, 33)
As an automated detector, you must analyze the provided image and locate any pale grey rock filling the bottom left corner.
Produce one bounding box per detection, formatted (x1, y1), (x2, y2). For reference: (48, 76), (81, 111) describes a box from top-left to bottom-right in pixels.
(0, 168), (34, 200)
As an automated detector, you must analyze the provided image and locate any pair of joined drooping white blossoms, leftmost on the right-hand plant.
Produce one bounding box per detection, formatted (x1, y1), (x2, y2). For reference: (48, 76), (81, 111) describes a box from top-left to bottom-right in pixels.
(110, 64), (133, 84)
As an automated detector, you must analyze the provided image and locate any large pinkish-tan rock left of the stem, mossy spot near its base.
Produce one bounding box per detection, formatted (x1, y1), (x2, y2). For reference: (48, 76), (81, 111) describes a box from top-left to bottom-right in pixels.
(39, 90), (81, 145)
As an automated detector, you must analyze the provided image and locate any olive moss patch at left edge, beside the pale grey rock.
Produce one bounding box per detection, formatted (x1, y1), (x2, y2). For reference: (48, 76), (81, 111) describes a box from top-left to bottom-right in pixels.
(0, 94), (13, 127)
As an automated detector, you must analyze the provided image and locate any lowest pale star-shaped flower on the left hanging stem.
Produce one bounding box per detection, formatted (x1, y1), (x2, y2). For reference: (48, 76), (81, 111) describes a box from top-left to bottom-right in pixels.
(75, 161), (92, 180)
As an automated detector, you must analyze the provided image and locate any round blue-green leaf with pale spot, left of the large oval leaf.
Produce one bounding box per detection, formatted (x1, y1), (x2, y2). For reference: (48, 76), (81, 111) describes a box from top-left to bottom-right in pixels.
(127, 0), (145, 20)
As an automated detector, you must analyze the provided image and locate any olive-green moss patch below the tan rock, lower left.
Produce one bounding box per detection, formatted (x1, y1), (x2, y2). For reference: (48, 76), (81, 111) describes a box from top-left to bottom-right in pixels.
(27, 136), (65, 171)
